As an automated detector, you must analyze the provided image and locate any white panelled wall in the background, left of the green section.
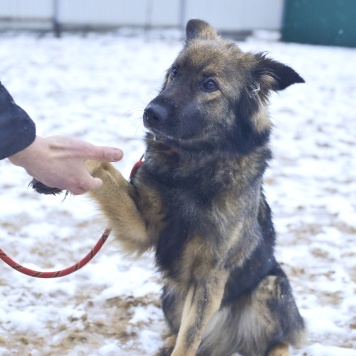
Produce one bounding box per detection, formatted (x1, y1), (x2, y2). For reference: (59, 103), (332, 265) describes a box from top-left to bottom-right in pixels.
(0, 0), (283, 31)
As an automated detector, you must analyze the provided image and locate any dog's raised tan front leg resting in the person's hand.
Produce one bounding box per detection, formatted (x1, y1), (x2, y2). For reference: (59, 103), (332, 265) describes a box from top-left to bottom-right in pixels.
(86, 161), (151, 253)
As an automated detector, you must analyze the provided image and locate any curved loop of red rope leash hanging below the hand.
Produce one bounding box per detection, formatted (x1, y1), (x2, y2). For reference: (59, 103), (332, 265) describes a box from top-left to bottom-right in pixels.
(0, 229), (111, 278)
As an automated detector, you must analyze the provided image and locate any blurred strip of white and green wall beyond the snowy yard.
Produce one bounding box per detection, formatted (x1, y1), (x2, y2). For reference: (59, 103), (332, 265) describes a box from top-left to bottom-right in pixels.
(0, 0), (356, 47)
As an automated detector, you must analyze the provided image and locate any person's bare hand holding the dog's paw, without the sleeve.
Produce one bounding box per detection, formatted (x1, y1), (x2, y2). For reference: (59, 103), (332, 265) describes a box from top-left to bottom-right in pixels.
(9, 136), (123, 194)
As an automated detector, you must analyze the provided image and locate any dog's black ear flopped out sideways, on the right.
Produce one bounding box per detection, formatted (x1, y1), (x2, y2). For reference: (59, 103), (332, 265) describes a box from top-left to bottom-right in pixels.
(253, 53), (305, 91)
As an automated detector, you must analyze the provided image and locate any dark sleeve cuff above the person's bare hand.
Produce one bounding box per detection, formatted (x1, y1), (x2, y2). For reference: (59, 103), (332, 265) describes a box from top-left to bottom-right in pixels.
(0, 83), (36, 159)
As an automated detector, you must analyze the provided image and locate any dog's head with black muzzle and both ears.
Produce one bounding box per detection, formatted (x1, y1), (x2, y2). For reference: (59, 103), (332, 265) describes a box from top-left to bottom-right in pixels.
(143, 20), (304, 153)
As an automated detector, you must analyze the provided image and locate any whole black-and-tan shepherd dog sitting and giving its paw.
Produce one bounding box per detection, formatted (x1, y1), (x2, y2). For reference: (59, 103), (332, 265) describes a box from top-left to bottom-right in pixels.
(32, 20), (304, 356)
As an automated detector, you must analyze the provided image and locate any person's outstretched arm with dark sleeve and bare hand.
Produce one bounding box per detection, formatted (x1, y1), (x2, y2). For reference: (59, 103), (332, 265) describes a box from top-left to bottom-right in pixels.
(0, 83), (123, 194)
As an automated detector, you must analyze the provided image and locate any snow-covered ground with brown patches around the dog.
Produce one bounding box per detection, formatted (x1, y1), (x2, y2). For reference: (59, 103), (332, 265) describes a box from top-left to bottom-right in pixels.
(0, 28), (356, 356)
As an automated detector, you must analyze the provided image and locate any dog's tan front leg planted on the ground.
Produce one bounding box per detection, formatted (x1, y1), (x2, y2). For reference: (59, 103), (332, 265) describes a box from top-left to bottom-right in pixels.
(172, 266), (228, 356)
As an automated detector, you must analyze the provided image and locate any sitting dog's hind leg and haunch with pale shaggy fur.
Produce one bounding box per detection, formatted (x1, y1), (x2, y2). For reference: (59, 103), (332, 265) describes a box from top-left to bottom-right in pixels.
(198, 266), (304, 356)
